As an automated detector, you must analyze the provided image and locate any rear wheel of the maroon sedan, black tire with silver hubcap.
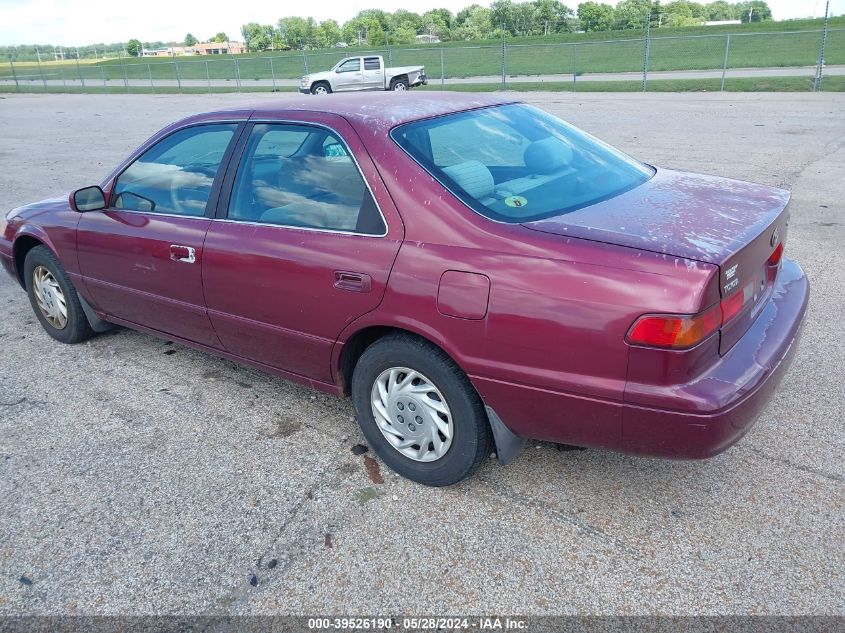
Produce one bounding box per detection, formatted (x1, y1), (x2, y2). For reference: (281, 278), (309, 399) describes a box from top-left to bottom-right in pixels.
(352, 334), (492, 486)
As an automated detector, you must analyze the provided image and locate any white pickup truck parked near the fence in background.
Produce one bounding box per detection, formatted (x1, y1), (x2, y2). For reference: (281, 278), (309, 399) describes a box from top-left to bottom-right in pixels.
(299, 55), (427, 95)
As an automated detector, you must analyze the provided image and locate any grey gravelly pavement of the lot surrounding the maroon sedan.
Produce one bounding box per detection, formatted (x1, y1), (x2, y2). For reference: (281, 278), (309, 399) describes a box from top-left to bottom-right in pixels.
(0, 93), (845, 615)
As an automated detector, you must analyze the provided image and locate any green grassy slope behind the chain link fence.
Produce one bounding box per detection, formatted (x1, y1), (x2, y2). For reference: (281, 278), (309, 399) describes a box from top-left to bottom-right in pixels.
(0, 18), (845, 85)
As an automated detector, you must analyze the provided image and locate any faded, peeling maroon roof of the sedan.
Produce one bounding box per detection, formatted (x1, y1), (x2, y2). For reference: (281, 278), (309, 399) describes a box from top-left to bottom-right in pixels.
(208, 91), (515, 130)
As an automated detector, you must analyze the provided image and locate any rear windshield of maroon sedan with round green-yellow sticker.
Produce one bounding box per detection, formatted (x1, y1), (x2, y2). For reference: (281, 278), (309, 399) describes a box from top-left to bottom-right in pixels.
(391, 104), (654, 223)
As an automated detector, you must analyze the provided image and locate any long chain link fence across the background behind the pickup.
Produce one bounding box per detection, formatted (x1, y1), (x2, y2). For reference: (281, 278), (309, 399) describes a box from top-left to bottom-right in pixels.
(0, 26), (845, 92)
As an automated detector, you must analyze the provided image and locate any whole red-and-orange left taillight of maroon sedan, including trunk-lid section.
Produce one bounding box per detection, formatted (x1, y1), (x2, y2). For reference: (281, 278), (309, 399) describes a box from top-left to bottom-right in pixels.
(626, 283), (754, 349)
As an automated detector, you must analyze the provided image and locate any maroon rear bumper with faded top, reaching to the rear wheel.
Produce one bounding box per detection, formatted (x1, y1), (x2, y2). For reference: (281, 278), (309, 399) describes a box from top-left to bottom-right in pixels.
(471, 259), (809, 459)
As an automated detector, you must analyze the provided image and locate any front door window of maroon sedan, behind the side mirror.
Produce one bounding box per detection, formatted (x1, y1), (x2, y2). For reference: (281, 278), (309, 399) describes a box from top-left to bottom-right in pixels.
(112, 123), (237, 216)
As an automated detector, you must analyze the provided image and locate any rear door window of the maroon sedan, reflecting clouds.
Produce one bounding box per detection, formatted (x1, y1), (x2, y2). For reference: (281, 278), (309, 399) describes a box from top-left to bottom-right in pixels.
(228, 124), (385, 235)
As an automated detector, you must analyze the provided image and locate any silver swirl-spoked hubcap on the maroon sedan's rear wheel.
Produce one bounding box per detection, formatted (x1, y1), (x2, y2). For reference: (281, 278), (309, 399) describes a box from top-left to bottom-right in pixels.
(370, 367), (454, 462)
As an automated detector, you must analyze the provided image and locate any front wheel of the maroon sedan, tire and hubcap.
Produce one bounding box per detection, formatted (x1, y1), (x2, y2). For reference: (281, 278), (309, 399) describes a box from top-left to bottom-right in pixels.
(23, 246), (94, 343)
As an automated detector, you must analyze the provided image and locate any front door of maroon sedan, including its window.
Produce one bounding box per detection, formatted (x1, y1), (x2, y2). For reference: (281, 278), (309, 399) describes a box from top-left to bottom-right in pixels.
(77, 118), (238, 347)
